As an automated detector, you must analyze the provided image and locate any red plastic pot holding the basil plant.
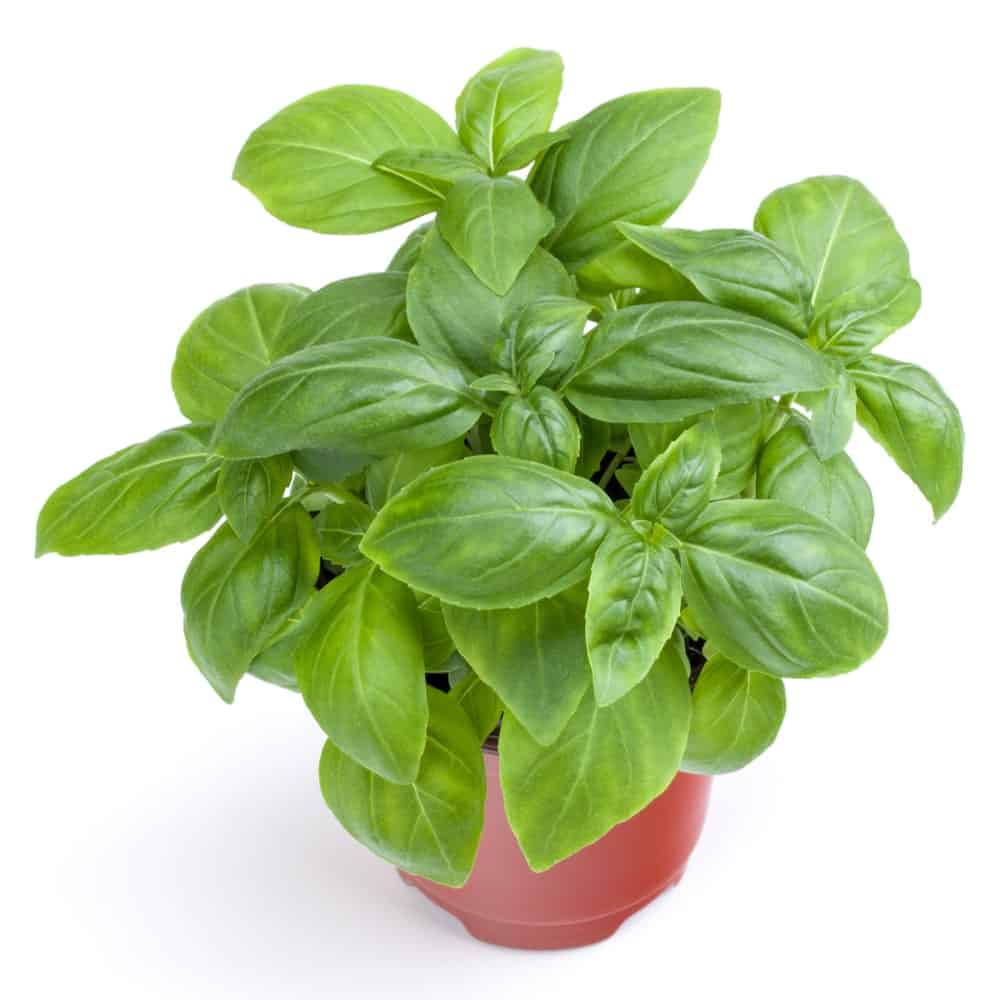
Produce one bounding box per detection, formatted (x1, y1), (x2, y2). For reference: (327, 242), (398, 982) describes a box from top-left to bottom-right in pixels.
(400, 747), (712, 948)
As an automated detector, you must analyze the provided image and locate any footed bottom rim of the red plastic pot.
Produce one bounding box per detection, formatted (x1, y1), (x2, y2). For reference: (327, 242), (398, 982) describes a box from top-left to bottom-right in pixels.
(399, 867), (684, 951)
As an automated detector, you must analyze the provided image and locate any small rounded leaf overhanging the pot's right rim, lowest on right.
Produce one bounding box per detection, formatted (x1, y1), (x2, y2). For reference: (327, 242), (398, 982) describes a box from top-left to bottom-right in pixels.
(681, 656), (785, 774)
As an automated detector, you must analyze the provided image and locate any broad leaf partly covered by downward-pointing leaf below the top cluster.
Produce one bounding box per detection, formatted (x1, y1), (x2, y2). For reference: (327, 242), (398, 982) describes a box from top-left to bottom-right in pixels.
(406, 227), (573, 375)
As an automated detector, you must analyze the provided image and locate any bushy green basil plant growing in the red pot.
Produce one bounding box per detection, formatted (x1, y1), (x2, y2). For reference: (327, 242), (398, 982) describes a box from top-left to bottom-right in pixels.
(38, 49), (963, 885)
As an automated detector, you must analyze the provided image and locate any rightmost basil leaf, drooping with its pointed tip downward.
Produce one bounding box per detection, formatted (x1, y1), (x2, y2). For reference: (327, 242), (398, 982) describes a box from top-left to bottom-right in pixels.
(848, 354), (965, 520)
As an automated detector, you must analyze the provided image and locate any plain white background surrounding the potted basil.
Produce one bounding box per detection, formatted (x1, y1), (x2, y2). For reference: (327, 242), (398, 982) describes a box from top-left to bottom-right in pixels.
(0, 0), (1000, 1000)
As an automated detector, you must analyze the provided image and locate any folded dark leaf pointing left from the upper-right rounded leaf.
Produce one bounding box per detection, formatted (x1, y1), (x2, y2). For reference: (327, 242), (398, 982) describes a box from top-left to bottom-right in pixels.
(619, 223), (811, 337)
